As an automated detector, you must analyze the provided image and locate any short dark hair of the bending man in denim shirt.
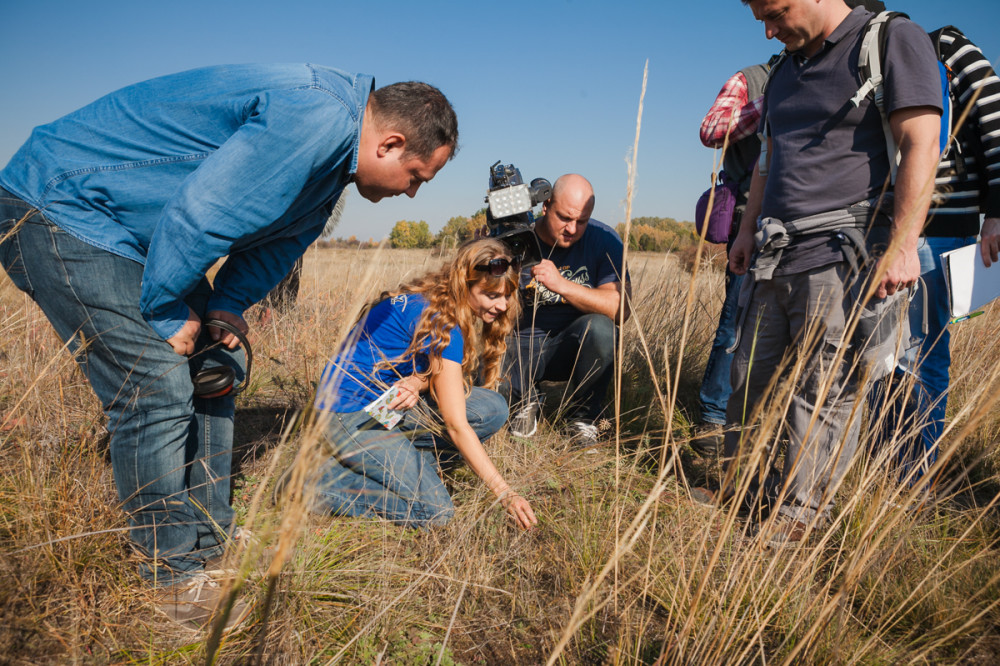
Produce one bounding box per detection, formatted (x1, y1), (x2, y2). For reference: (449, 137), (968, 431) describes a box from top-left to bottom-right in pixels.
(369, 81), (458, 160)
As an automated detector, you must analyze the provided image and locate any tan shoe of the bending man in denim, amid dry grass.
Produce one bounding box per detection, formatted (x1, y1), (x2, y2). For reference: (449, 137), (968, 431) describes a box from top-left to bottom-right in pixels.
(155, 573), (253, 632)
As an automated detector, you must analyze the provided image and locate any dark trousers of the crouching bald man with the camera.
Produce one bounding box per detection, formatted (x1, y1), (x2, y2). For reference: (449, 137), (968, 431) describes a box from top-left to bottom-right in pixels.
(504, 314), (615, 419)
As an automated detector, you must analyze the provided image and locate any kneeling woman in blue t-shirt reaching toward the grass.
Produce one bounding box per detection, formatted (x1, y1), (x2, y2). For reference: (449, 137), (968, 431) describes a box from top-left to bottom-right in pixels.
(308, 239), (537, 529)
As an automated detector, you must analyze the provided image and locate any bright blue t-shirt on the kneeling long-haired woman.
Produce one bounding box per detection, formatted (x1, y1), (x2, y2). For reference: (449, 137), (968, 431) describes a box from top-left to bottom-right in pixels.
(316, 294), (464, 412)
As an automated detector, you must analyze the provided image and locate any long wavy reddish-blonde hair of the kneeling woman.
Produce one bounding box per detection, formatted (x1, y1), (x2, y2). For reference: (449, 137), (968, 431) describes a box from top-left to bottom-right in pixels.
(370, 238), (521, 389)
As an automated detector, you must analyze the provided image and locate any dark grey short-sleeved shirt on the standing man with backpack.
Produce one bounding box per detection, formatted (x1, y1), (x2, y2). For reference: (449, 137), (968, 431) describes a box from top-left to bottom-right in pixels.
(762, 7), (941, 274)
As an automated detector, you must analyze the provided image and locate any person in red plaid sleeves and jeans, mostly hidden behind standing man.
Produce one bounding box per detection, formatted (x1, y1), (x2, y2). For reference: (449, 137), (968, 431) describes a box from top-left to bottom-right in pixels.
(691, 64), (769, 456)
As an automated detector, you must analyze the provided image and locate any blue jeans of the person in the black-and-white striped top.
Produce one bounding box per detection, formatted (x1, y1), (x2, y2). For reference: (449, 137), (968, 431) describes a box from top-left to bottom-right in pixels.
(876, 236), (976, 478)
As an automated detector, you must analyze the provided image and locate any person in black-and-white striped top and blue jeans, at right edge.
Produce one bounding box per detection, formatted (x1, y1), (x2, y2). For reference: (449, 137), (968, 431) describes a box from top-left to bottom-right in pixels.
(870, 20), (1000, 482)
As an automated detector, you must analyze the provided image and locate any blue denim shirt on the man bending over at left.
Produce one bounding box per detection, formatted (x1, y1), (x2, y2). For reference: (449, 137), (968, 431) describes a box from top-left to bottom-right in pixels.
(0, 64), (374, 339)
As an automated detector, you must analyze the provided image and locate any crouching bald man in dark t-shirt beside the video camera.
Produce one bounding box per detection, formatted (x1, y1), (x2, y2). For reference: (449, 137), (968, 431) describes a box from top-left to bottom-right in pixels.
(505, 174), (628, 447)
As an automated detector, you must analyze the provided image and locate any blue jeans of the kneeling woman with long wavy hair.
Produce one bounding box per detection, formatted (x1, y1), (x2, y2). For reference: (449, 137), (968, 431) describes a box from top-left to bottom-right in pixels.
(318, 387), (507, 527)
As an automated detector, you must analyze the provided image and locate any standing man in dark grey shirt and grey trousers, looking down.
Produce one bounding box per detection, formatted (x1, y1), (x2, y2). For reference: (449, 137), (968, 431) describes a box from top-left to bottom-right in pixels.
(714, 0), (941, 546)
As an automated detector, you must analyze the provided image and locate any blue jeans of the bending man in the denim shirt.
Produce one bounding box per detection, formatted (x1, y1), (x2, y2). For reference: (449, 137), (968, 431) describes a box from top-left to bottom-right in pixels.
(0, 189), (243, 584)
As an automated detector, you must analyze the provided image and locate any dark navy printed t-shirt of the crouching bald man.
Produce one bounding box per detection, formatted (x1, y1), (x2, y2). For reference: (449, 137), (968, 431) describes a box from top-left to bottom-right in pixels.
(518, 218), (625, 334)
